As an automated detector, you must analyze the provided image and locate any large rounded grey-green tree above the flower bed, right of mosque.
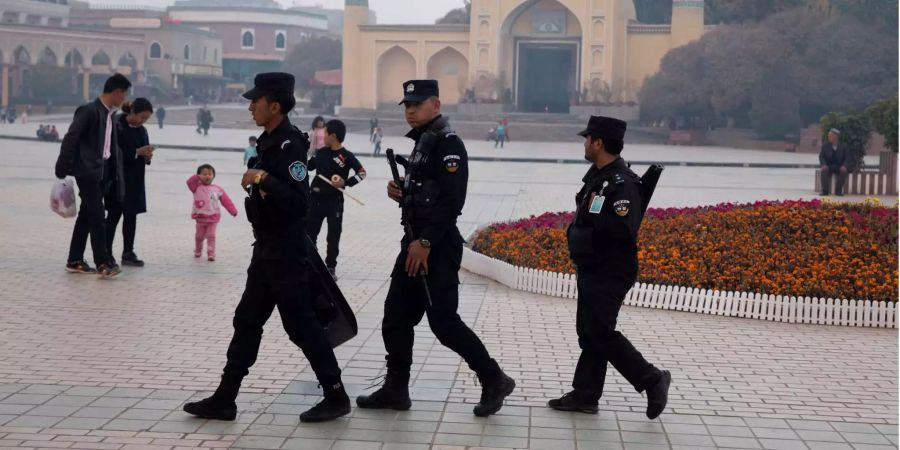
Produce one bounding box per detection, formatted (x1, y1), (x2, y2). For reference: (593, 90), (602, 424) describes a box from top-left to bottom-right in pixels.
(638, 7), (898, 134)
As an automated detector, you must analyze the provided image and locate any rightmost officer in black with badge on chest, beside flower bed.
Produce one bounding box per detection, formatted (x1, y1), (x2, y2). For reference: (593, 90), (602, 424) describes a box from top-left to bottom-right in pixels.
(549, 116), (672, 419)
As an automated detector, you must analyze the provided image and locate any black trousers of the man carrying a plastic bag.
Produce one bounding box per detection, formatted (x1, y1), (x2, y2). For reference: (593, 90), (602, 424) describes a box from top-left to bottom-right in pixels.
(69, 178), (112, 264)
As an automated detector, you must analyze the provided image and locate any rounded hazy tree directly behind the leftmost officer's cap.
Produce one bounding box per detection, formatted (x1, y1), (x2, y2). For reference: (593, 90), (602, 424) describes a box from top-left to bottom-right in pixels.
(283, 36), (342, 94)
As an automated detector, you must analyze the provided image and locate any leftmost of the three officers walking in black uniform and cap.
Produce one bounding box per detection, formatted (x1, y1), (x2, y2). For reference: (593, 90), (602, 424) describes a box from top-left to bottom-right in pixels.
(184, 73), (350, 422)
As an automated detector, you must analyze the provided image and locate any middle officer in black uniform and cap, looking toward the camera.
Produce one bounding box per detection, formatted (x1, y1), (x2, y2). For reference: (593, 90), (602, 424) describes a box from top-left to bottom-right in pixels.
(356, 80), (516, 416)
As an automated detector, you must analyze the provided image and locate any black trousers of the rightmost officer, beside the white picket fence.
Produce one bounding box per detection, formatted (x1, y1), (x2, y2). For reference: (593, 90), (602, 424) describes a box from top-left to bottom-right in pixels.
(572, 270), (661, 400)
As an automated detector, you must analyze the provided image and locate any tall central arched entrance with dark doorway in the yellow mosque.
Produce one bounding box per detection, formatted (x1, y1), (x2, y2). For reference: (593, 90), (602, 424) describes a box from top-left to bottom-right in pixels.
(500, 0), (582, 113)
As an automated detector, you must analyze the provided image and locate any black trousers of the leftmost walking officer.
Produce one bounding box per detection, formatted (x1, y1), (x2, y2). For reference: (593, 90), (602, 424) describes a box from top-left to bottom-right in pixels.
(223, 256), (341, 387)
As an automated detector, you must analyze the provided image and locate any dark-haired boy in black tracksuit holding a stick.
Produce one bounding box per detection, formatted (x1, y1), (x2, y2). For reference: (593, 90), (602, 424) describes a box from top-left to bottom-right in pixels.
(306, 120), (366, 279)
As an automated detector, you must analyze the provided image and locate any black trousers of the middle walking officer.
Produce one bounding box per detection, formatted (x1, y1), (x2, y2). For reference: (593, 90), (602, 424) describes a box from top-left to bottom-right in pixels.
(381, 238), (500, 377)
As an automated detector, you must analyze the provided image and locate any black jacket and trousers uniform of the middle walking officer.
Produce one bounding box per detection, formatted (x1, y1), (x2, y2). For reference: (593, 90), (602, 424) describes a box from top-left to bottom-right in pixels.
(382, 116), (500, 380)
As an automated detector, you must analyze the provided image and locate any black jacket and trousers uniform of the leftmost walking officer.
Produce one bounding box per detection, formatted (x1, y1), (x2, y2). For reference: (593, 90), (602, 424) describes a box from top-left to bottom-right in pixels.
(222, 74), (345, 398)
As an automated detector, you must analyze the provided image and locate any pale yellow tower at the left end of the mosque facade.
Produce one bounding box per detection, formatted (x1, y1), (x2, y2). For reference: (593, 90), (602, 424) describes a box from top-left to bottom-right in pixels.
(341, 0), (369, 108)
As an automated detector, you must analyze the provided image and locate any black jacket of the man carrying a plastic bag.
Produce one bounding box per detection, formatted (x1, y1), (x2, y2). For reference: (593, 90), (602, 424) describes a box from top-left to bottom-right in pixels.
(55, 98), (125, 200)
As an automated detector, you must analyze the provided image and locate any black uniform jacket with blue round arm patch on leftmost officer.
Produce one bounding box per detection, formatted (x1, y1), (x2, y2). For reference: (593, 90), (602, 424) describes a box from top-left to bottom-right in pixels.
(245, 117), (309, 259)
